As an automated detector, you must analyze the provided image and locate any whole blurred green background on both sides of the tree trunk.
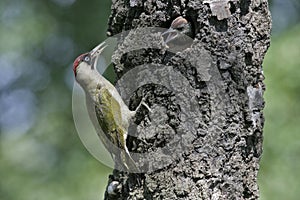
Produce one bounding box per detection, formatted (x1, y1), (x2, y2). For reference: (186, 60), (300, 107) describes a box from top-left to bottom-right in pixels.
(0, 0), (300, 200)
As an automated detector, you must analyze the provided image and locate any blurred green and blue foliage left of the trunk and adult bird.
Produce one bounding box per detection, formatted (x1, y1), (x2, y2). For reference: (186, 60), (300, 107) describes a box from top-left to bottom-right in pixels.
(0, 0), (111, 200)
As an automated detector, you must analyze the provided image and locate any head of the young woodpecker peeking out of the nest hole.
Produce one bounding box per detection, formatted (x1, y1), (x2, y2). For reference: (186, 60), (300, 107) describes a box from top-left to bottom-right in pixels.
(163, 16), (192, 43)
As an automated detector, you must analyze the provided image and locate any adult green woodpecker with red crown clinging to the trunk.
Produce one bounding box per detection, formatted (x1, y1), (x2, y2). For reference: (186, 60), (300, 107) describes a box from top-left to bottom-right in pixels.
(73, 42), (150, 172)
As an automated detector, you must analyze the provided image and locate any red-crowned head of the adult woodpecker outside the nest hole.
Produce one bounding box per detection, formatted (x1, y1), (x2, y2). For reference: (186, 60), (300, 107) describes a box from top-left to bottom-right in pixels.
(73, 42), (106, 86)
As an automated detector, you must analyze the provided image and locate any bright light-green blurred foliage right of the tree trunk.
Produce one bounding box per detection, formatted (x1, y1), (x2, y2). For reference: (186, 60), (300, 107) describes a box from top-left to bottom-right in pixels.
(259, 25), (300, 200)
